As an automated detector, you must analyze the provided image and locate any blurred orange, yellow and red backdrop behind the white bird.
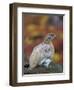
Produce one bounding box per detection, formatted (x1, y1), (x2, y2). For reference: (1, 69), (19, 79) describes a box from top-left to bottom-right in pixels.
(22, 13), (63, 67)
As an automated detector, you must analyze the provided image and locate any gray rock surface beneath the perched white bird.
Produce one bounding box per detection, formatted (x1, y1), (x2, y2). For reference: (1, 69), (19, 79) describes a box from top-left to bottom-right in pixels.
(24, 62), (63, 74)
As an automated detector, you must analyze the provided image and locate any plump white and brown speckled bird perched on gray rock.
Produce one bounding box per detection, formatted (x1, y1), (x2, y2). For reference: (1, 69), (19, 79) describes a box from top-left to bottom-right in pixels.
(29, 33), (56, 70)
